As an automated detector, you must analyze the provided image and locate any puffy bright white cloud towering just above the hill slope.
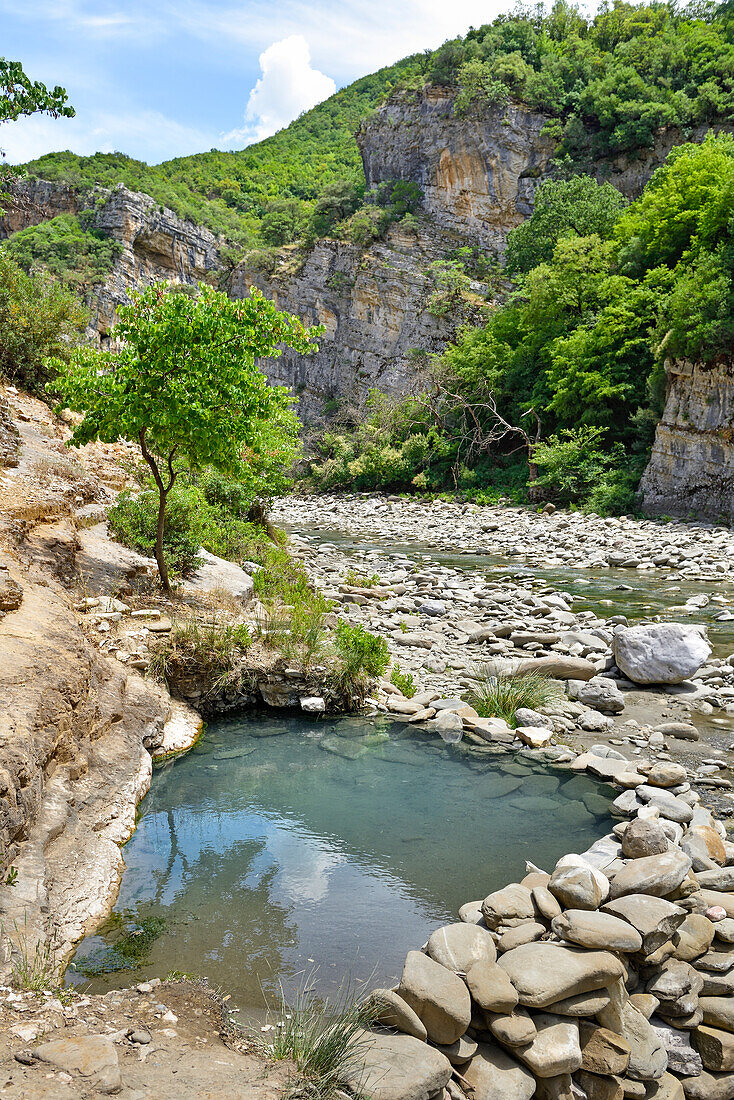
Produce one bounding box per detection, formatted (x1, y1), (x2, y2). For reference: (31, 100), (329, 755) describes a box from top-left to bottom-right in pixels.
(221, 34), (337, 145)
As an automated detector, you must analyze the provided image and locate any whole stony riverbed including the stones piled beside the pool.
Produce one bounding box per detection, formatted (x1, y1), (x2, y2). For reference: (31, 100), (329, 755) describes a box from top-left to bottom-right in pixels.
(268, 498), (734, 1100)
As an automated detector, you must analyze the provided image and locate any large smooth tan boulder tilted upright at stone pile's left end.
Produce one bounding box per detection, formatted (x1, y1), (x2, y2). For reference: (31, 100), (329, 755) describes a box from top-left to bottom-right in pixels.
(397, 950), (471, 1046)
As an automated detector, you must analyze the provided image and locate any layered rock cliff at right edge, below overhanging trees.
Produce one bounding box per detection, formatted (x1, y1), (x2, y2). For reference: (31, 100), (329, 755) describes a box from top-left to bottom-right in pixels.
(640, 360), (734, 524)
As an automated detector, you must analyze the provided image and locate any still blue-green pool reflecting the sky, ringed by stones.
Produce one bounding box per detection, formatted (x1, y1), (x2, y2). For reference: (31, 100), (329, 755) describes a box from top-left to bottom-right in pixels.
(68, 715), (611, 1015)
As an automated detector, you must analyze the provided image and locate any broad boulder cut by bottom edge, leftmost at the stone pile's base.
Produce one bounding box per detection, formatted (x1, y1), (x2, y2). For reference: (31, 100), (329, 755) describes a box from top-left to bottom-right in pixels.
(350, 1032), (452, 1100)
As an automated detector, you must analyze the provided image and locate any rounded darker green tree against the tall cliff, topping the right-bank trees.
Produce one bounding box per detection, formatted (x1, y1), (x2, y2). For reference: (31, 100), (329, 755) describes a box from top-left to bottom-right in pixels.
(505, 176), (626, 275)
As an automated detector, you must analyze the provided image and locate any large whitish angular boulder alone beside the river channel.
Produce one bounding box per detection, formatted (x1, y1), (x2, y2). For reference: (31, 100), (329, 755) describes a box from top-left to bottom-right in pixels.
(612, 623), (711, 684)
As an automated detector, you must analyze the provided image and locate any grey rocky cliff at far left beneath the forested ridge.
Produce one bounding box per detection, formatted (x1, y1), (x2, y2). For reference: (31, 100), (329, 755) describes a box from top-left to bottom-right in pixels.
(0, 179), (222, 341)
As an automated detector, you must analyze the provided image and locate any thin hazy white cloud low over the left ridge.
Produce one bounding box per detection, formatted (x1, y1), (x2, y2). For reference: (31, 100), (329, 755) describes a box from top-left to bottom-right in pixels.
(0, 111), (216, 164)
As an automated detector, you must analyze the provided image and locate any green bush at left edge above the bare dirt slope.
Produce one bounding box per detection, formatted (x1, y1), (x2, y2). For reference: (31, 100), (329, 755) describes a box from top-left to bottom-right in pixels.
(0, 248), (87, 393)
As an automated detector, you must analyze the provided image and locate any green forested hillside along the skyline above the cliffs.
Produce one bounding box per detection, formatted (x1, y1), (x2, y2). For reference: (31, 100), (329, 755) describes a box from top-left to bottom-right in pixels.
(17, 0), (734, 245)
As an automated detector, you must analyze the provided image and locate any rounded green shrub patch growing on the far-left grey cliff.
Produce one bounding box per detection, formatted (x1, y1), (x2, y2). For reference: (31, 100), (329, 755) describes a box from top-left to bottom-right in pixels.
(4, 213), (122, 292)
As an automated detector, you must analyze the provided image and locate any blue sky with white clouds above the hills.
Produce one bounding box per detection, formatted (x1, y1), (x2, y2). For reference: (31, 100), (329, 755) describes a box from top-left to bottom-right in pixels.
(0, 0), (512, 164)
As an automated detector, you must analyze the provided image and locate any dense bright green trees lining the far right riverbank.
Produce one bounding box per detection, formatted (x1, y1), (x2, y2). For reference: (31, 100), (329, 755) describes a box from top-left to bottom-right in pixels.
(310, 133), (734, 512)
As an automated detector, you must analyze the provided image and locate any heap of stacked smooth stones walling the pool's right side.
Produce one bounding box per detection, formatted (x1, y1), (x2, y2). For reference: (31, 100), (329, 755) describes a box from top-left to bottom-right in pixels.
(362, 761), (734, 1100)
